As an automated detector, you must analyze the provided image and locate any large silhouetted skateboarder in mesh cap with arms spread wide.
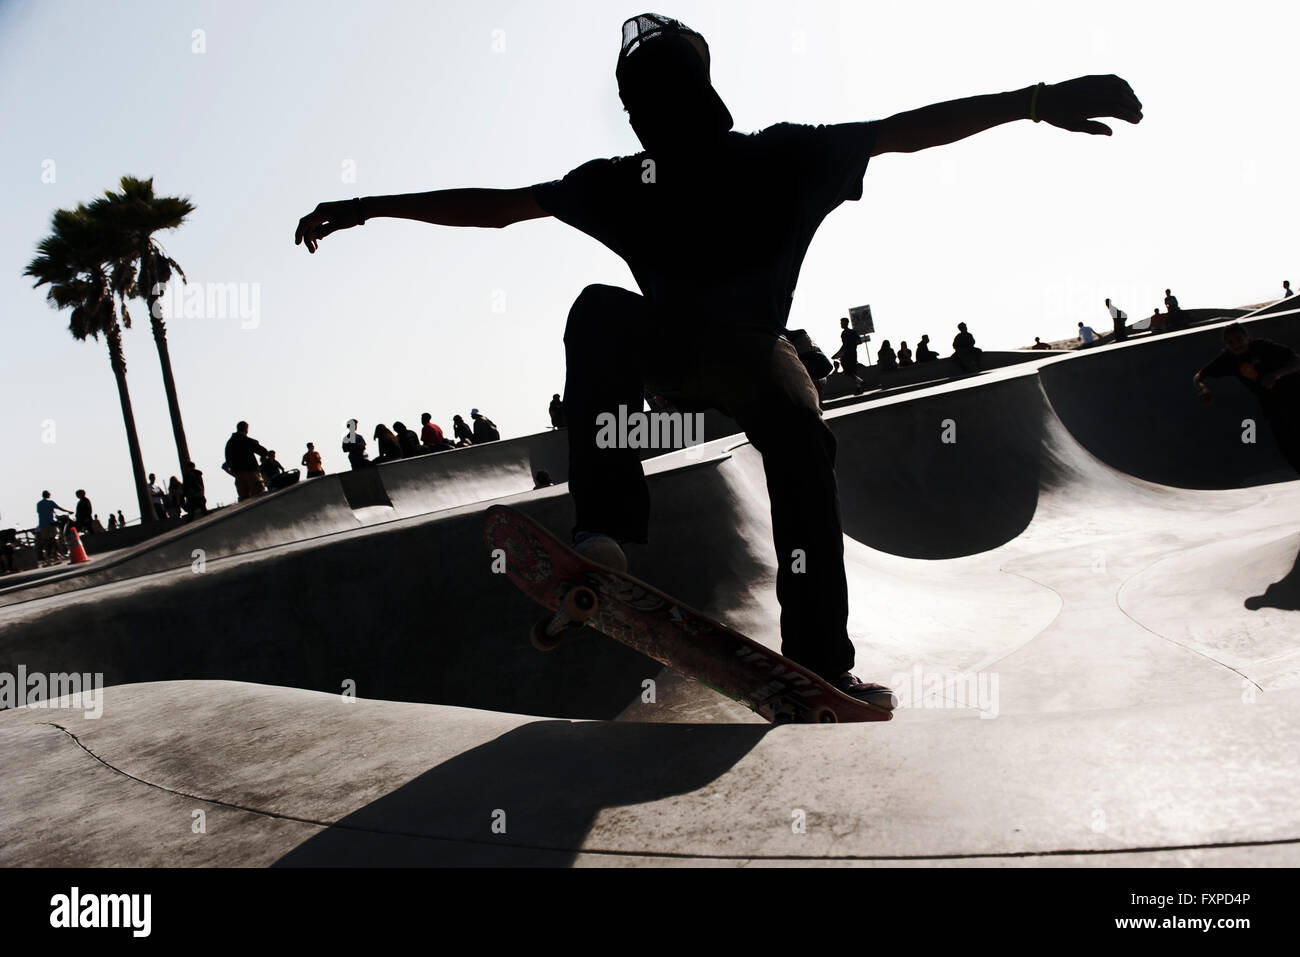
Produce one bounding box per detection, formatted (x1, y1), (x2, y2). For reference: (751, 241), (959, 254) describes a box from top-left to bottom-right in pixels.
(295, 14), (1141, 703)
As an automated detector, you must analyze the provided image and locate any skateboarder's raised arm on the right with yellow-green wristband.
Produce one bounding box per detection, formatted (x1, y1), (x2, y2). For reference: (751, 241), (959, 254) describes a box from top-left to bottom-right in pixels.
(872, 75), (1141, 156)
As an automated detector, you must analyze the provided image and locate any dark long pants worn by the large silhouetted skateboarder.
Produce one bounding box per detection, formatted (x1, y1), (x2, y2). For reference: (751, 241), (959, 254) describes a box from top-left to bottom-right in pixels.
(564, 286), (853, 677)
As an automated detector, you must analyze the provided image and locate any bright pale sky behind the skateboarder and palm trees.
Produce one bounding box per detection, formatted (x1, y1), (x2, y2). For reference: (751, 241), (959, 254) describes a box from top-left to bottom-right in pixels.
(0, 0), (1300, 525)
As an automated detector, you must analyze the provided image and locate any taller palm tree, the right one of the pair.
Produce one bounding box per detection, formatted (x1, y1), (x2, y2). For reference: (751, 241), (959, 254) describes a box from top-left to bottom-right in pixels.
(90, 176), (194, 475)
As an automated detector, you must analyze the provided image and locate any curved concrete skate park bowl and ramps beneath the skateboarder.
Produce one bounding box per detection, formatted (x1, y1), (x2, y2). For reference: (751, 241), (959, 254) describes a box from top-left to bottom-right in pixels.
(0, 302), (1300, 866)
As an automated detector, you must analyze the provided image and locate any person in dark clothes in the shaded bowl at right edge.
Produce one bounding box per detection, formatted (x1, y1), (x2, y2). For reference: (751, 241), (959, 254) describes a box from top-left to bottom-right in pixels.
(1192, 322), (1300, 473)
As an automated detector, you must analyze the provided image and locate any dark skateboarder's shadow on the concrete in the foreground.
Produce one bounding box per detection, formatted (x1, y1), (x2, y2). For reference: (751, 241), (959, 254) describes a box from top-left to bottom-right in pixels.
(276, 720), (772, 867)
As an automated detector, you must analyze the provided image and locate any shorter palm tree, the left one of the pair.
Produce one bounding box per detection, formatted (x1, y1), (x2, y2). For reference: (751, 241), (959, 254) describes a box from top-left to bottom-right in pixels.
(23, 204), (153, 523)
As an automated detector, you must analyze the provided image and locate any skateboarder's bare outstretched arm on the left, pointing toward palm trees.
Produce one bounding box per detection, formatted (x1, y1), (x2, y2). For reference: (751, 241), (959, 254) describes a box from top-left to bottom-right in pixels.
(294, 186), (550, 252)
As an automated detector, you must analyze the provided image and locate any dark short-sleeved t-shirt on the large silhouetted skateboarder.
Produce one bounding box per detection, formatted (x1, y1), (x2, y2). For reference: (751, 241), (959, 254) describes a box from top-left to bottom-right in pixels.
(533, 122), (876, 333)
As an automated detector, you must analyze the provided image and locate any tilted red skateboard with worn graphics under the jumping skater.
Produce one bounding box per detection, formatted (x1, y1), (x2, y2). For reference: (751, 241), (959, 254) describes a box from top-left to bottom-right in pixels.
(484, 505), (893, 724)
